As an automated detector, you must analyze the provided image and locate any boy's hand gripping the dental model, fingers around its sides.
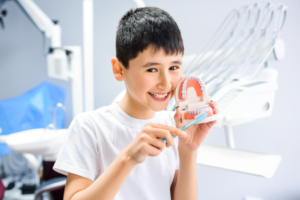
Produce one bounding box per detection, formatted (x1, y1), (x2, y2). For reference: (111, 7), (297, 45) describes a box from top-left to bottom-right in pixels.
(174, 102), (219, 151)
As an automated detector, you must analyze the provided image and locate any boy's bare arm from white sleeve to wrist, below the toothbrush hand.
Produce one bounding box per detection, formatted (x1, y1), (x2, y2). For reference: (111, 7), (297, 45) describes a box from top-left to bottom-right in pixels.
(64, 150), (135, 200)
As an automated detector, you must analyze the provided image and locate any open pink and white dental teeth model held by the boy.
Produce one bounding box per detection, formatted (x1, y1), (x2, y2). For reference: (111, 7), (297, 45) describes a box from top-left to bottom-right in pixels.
(175, 76), (217, 124)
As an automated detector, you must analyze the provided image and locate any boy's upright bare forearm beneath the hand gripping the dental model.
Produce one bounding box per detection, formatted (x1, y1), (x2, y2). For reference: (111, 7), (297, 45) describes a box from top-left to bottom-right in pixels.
(171, 146), (198, 200)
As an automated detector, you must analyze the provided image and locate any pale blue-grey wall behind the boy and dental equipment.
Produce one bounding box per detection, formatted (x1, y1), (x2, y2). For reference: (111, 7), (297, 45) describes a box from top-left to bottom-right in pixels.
(0, 0), (300, 200)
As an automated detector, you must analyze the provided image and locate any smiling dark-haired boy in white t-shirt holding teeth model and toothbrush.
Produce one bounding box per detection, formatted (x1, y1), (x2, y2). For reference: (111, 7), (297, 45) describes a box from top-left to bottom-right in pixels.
(54, 7), (218, 200)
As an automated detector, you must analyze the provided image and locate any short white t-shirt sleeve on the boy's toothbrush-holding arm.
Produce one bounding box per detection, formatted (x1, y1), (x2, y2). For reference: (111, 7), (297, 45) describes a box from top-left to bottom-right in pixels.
(53, 113), (100, 181)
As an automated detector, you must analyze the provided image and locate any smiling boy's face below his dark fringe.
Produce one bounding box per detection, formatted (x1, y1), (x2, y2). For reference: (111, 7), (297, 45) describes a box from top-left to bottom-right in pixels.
(123, 46), (182, 111)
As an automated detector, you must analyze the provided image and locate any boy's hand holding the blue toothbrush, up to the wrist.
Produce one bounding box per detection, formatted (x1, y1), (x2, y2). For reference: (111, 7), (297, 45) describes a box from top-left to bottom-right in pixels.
(126, 123), (187, 164)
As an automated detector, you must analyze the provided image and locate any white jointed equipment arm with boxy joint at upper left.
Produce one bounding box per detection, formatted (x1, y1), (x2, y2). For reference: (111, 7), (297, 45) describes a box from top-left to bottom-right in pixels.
(0, 0), (83, 117)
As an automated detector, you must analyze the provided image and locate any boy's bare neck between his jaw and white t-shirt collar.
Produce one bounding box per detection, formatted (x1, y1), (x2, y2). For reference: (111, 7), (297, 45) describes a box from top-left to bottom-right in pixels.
(118, 91), (155, 119)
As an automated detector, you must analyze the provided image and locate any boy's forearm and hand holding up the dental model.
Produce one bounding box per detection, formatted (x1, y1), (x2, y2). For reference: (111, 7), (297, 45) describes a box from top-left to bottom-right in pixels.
(171, 102), (219, 200)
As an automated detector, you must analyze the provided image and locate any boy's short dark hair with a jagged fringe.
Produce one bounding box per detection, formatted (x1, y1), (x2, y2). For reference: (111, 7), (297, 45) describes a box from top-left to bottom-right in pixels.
(116, 7), (184, 68)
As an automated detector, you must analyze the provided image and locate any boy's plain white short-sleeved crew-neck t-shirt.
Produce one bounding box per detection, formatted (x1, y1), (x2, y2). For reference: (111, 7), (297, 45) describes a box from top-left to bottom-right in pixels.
(53, 103), (179, 200)
